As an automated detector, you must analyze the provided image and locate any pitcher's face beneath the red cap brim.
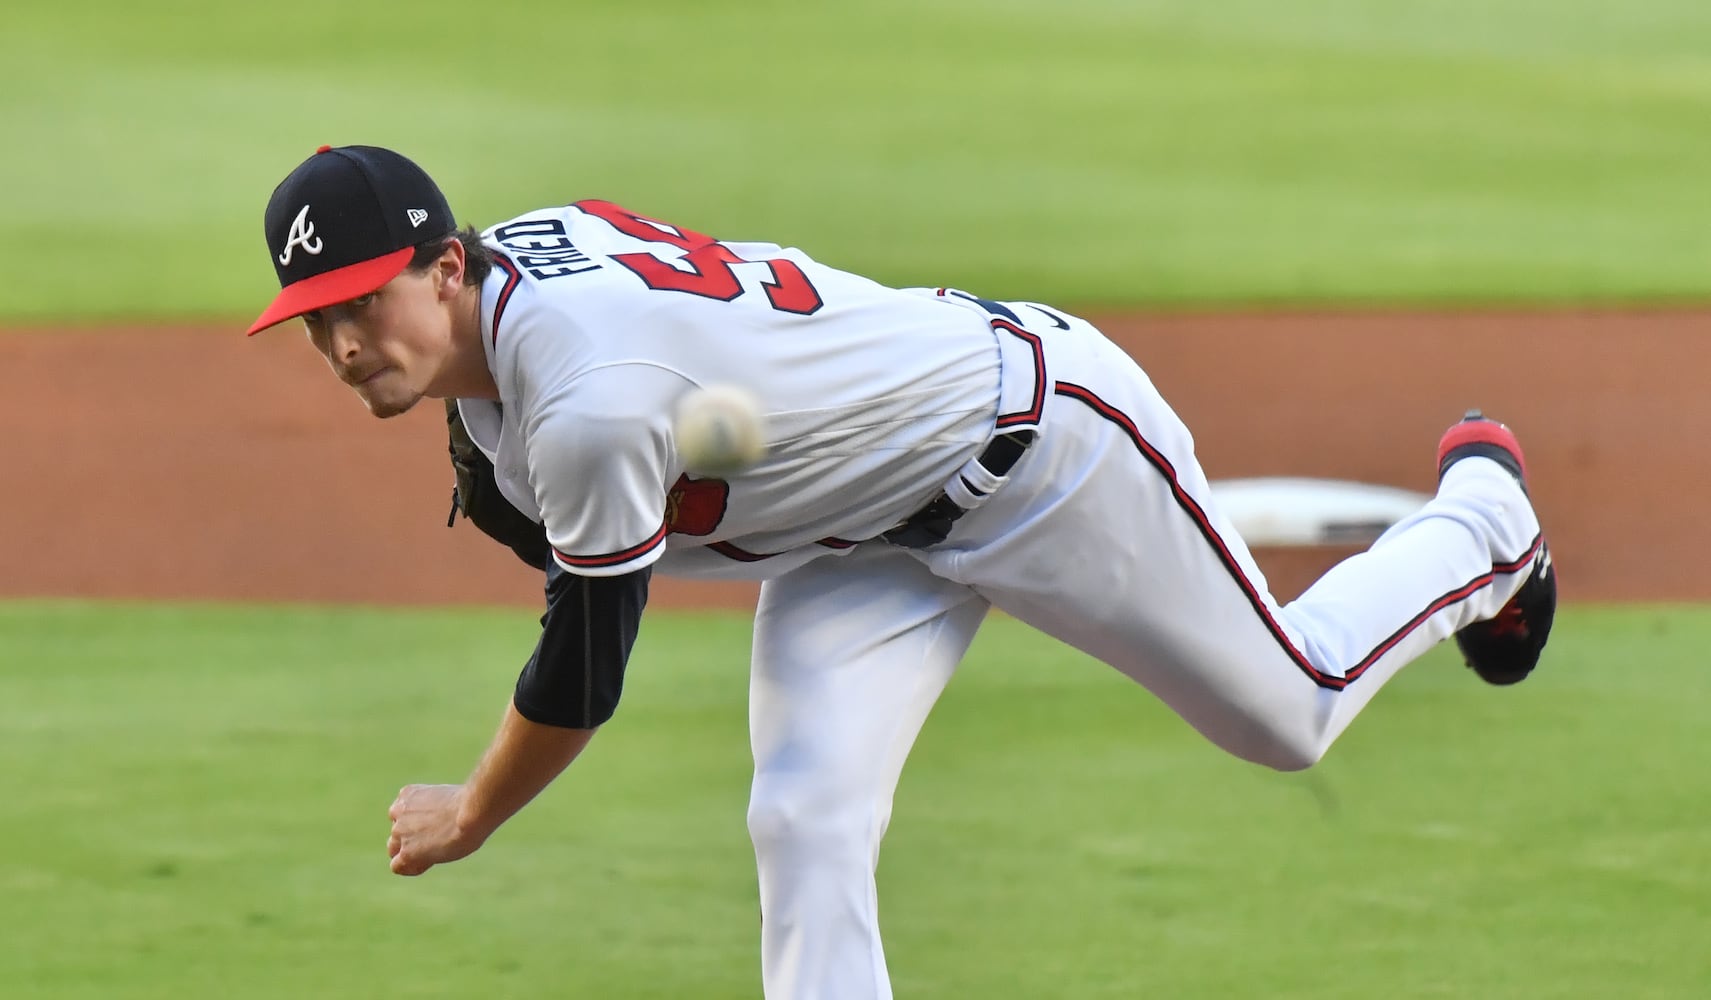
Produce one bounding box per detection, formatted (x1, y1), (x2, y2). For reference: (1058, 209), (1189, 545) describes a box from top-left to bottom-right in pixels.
(303, 269), (452, 418)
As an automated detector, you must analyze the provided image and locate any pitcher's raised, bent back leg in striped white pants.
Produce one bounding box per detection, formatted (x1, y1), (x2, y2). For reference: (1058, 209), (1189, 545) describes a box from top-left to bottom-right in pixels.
(927, 316), (1543, 769)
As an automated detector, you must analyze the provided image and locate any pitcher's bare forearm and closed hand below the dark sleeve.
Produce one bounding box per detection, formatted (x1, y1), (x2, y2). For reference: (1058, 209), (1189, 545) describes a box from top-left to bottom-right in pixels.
(387, 705), (594, 875)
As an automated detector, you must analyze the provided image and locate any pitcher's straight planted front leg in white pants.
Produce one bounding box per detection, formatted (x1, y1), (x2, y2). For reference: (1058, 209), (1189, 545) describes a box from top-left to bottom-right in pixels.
(749, 545), (987, 1000)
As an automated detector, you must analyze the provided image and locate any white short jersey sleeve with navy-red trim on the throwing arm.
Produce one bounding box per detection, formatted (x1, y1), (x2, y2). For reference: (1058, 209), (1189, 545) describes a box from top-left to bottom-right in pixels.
(524, 365), (688, 577)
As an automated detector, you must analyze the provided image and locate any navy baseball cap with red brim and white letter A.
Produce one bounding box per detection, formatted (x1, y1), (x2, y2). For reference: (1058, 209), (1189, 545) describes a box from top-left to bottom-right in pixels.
(250, 146), (457, 336)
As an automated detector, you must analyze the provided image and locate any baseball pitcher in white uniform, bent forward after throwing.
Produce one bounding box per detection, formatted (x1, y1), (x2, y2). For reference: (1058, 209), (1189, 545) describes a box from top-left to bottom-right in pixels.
(250, 146), (1557, 1000)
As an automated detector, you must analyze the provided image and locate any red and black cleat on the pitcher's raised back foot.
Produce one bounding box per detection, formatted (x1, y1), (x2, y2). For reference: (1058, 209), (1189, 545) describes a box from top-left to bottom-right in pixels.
(1437, 409), (1557, 685)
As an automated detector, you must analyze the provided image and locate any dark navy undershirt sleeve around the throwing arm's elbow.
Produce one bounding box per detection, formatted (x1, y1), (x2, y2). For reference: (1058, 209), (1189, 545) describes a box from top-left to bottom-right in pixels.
(512, 560), (654, 729)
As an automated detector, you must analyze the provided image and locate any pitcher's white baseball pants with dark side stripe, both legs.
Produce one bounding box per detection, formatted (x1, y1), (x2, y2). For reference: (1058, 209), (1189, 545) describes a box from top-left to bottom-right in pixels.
(748, 308), (1540, 1000)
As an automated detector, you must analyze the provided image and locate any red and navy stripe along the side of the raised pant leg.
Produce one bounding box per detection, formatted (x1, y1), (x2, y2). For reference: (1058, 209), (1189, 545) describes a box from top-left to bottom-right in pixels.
(1056, 382), (1543, 692)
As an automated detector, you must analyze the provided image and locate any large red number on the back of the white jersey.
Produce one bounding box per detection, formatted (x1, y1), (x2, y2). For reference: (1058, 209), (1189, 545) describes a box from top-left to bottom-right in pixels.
(575, 200), (823, 317)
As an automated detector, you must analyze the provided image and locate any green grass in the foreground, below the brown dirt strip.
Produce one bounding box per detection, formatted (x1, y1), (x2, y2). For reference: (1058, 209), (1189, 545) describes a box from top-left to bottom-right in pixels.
(0, 603), (1711, 1000)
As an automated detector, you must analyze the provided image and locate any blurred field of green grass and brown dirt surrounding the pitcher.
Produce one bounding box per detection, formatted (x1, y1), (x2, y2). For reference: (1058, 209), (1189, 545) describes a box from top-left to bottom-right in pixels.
(0, 0), (1711, 998)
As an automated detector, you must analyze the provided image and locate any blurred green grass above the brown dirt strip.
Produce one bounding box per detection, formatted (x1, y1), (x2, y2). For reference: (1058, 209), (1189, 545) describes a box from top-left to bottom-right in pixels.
(0, 0), (1711, 325)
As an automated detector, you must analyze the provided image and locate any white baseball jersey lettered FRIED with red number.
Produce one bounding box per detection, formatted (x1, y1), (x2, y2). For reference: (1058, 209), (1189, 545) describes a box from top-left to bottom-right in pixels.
(459, 200), (1044, 579)
